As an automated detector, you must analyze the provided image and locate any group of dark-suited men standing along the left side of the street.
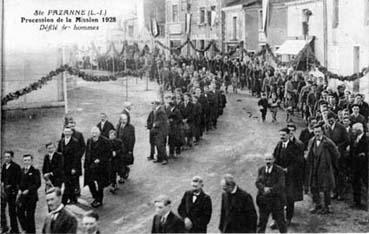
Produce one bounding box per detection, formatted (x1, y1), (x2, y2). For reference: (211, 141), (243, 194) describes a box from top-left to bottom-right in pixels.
(1, 107), (135, 233)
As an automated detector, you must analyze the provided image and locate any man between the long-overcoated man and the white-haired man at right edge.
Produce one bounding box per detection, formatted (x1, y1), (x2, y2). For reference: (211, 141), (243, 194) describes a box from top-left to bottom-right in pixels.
(324, 112), (350, 201)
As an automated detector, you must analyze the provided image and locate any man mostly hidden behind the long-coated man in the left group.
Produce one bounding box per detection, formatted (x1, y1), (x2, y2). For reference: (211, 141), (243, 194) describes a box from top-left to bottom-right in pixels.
(68, 121), (86, 196)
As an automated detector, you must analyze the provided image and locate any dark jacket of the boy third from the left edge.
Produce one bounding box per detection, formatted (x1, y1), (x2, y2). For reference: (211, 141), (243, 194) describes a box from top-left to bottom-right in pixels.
(42, 152), (64, 187)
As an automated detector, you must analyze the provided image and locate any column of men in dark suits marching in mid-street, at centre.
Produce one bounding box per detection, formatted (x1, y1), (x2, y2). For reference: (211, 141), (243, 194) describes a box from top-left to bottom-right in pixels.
(146, 66), (227, 165)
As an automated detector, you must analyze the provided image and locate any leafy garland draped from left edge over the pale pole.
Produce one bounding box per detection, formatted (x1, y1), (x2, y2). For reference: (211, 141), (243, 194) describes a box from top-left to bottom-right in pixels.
(1, 64), (150, 105)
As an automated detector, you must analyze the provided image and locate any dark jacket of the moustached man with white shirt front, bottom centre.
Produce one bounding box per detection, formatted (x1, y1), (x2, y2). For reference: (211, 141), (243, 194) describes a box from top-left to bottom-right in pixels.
(178, 190), (212, 233)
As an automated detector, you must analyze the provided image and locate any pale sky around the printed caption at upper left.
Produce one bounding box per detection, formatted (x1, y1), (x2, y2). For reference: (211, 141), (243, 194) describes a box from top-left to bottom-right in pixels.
(4, 0), (140, 51)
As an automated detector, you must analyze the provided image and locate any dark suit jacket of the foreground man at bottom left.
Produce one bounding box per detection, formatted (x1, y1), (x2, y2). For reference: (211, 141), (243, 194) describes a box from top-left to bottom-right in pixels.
(42, 208), (78, 234)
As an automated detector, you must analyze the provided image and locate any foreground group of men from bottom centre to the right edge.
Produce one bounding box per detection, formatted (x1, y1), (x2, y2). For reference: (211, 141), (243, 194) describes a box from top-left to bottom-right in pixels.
(151, 117), (369, 233)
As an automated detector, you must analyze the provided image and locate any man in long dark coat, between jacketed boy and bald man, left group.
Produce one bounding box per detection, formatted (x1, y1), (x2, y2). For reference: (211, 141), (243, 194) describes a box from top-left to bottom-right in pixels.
(57, 127), (81, 205)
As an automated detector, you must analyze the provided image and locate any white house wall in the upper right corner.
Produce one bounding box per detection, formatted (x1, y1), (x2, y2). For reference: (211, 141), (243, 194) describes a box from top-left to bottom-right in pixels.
(327, 0), (369, 100)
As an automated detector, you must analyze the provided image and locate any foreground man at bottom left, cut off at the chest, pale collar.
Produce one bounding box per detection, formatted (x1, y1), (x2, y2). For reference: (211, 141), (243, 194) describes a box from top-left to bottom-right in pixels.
(42, 188), (78, 234)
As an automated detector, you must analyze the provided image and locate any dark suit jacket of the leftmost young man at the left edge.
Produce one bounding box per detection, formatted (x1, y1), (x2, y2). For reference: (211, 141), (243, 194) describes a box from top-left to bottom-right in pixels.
(1, 161), (22, 195)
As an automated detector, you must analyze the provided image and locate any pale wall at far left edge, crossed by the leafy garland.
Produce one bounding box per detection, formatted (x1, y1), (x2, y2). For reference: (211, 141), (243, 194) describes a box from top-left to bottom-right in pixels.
(2, 47), (63, 108)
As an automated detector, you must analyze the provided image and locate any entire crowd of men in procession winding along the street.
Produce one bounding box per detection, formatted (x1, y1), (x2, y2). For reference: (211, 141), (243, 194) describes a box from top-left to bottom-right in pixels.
(1, 51), (369, 233)
